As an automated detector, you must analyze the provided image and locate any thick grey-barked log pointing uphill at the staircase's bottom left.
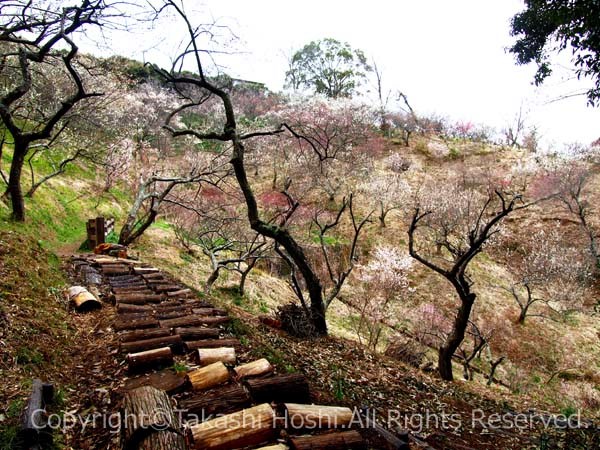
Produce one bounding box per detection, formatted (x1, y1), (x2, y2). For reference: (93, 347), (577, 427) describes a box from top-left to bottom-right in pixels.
(121, 386), (187, 450)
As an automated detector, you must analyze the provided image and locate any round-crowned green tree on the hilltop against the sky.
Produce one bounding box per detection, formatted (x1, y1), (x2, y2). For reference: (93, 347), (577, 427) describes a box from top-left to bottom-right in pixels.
(286, 38), (372, 98)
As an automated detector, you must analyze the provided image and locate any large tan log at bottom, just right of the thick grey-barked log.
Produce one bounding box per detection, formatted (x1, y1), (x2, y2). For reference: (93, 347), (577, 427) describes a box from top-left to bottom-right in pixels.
(190, 403), (276, 450)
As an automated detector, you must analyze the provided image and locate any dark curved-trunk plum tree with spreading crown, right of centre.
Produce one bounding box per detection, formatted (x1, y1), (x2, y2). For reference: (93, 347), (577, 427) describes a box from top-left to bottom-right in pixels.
(408, 179), (529, 380)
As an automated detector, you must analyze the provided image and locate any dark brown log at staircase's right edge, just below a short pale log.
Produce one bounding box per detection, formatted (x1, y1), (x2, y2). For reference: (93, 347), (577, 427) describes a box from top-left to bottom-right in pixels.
(244, 373), (310, 403)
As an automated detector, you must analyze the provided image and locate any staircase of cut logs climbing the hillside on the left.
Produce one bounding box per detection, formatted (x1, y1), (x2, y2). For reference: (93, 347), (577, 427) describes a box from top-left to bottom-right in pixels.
(72, 255), (409, 450)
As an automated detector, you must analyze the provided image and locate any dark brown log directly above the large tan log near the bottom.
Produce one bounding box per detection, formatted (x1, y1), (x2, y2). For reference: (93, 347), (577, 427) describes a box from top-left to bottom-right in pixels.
(178, 385), (251, 417)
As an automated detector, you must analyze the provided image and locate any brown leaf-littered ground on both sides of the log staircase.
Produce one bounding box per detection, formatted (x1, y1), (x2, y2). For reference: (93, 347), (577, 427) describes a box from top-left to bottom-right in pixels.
(0, 233), (600, 450)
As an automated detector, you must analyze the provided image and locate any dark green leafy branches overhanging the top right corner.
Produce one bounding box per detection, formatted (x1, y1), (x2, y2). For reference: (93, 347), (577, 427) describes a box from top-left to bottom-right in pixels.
(510, 0), (600, 105)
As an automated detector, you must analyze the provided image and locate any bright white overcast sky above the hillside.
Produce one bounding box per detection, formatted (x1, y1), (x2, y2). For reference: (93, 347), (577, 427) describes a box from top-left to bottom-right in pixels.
(95, 0), (600, 146)
